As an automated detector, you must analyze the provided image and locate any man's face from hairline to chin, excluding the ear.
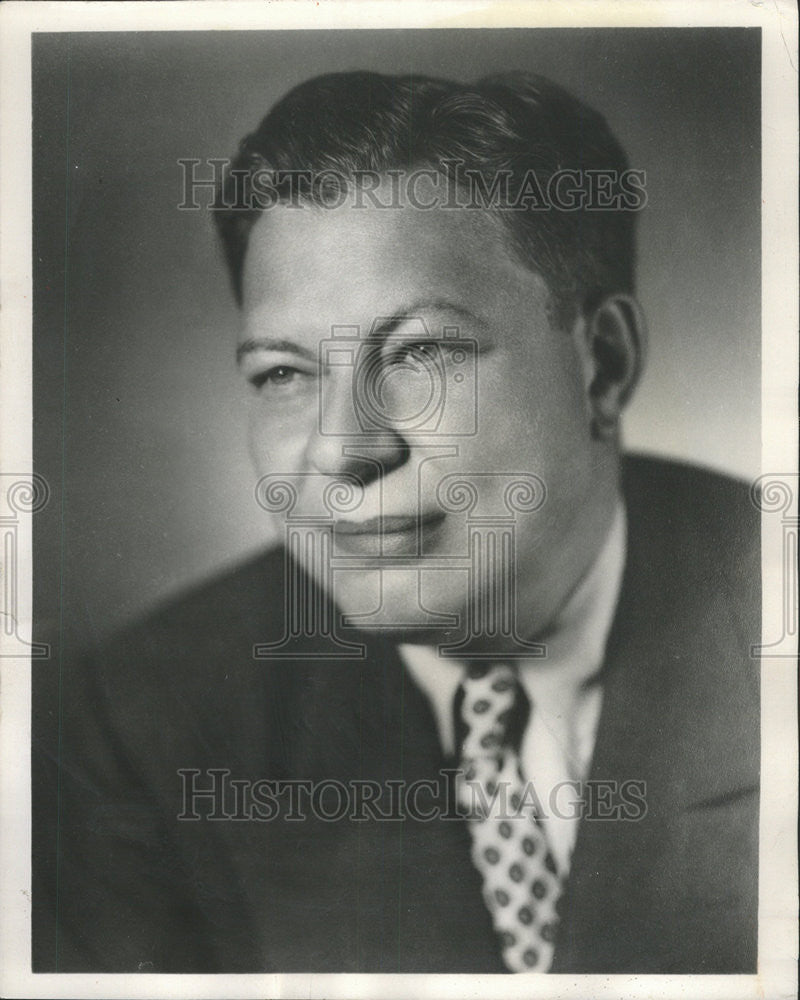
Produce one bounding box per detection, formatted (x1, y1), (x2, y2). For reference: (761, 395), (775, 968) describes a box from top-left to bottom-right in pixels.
(240, 180), (613, 651)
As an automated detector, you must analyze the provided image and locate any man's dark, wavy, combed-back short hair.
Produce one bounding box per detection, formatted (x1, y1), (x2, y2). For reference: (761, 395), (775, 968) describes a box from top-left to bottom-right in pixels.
(215, 72), (635, 326)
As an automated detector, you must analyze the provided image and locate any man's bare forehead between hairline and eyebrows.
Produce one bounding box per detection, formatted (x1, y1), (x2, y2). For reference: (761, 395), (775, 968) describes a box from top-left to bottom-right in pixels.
(243, 178), (546, 327)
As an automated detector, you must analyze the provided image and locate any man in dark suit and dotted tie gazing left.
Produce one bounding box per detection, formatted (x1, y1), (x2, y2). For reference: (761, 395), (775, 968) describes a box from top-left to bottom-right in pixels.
(35, 73), (758, 973)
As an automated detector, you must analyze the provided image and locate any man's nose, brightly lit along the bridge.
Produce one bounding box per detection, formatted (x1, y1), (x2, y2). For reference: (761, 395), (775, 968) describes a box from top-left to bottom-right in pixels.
(305, 375), (409, 486)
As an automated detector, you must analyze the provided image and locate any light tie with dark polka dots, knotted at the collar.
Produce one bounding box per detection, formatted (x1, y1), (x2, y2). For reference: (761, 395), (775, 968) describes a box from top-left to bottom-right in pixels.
(457, 663), (563, 972)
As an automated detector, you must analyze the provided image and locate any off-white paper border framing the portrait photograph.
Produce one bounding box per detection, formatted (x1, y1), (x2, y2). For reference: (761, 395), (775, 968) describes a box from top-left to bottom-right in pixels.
(0, 0), (798, 1000)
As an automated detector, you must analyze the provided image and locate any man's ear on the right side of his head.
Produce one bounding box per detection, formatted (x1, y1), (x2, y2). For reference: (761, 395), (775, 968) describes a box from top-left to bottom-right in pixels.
(584, 293), (647, 441)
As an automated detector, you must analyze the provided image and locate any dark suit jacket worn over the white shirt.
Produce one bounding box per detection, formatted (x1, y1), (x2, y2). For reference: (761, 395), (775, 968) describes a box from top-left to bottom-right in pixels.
(29, 458), (760, 973)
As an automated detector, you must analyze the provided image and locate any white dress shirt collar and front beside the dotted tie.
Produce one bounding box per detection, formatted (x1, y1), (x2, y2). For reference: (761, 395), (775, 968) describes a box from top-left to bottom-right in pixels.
(400, 502), (626, 877)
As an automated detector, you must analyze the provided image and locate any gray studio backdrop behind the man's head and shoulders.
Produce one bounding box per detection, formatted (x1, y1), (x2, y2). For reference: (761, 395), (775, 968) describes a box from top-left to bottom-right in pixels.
(33, 29), (761, 648)
